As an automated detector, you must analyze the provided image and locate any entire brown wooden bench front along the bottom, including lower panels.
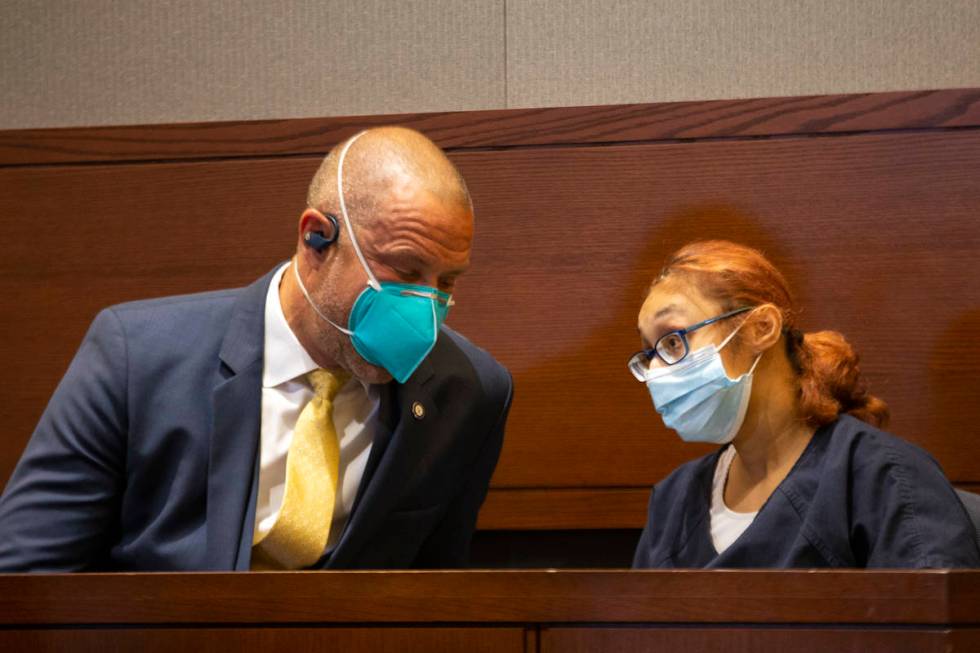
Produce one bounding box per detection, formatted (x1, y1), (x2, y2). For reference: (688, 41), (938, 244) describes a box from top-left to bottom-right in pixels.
(0, 570), (980, 653)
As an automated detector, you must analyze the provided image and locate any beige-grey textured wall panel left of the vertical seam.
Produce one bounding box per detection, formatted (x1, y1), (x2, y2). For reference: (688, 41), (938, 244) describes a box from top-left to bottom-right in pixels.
(0, 0), (505, 128)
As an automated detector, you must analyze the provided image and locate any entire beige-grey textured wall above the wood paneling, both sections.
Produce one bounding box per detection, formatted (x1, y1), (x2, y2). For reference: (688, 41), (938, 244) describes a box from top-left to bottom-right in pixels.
(0, 0), (980, 129)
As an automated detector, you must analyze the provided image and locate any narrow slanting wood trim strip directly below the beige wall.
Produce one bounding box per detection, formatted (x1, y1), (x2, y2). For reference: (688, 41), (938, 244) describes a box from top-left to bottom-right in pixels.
(0, 89), (980, 166)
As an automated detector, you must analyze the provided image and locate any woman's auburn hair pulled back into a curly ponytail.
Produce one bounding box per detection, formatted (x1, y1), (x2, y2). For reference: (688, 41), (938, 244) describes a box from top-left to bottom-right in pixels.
(651, 240), (889, 426)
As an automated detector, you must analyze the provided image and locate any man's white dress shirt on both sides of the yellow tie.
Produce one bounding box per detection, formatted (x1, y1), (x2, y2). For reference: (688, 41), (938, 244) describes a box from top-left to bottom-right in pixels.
(254, 264), (380, 551)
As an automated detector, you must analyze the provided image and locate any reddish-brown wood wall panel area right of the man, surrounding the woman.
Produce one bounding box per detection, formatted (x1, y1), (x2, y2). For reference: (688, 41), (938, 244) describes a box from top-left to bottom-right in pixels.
(453, 132), (980, 487)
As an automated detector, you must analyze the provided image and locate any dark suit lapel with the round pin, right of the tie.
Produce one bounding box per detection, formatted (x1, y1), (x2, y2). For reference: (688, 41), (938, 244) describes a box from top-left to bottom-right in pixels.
(323, 359), (439, 567)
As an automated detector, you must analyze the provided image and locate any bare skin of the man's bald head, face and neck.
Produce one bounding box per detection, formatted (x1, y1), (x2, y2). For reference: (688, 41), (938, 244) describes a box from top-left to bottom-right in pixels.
(288, 127), (473, 383)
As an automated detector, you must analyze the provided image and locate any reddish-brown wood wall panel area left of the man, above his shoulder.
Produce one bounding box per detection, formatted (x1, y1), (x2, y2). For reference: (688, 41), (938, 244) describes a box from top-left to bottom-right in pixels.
(0, 158), (317, 483)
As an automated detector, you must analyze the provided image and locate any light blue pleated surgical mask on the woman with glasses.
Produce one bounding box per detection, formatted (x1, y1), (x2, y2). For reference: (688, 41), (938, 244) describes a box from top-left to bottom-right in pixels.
(646, 325), (762, 444)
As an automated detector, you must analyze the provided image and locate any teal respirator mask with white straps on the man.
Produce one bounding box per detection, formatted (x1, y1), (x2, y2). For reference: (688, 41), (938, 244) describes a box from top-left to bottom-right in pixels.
(292, 132), (453, 383)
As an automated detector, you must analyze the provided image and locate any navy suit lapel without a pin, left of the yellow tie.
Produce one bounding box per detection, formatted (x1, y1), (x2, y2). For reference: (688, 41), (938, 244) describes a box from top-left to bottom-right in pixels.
(201, 272), (273, 570)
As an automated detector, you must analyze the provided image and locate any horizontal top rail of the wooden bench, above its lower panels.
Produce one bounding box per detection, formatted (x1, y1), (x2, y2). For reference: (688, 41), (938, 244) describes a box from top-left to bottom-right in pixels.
(0, 570), (980, 627)
